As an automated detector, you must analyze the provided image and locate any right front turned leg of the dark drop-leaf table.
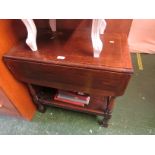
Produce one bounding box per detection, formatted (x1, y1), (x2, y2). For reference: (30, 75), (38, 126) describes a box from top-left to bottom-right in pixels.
(99, 96), (116, 127)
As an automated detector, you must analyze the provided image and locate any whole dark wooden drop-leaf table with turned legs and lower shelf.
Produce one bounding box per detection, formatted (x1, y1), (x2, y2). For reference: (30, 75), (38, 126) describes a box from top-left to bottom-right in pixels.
(3, 30), (133, 127)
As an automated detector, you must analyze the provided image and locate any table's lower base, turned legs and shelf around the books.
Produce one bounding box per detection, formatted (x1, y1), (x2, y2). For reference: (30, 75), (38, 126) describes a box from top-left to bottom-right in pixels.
(27, 84), (115, 127)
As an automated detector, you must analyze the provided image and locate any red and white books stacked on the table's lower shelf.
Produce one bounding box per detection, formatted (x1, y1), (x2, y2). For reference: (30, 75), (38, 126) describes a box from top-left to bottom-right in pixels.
(54, 90), (90, 107)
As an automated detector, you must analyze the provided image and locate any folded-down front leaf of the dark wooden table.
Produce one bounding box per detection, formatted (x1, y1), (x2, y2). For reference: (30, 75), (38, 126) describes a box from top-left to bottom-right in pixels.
(5, 59), (130, 96)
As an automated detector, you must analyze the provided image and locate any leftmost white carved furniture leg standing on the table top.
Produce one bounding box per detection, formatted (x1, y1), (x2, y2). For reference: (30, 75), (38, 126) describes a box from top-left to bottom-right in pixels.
(22, 19), (38, 51)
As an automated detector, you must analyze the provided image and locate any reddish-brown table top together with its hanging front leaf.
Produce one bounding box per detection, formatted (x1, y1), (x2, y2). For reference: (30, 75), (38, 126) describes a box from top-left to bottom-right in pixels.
(4, 30), (133, 96)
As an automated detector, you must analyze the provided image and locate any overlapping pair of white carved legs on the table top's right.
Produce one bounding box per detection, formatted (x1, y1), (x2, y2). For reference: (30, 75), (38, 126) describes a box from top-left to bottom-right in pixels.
(91, 19), (106, 58)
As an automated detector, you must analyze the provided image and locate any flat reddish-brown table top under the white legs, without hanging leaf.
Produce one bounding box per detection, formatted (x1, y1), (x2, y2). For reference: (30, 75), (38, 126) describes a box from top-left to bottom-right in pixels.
(5, 29), (133, 73)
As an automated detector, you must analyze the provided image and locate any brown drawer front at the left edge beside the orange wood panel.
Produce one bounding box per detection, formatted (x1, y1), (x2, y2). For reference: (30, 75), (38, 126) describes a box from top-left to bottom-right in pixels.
(0, 88), (20, 116)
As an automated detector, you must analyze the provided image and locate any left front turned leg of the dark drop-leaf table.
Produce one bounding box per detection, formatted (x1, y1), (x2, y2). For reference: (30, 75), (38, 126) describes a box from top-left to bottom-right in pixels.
(27, 84), (46, 113)
